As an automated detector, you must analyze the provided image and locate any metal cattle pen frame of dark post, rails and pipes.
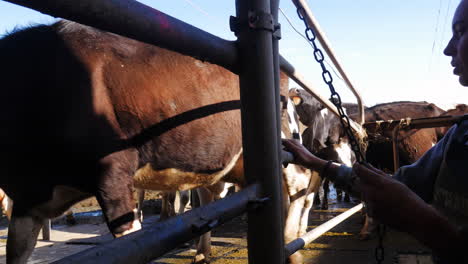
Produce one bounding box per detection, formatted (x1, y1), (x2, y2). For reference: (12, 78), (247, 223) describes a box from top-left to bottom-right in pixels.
(0, 0), (458, 264)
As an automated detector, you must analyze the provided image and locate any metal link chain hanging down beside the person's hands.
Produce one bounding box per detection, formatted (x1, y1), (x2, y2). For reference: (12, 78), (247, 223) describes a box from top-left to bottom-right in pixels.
(297, 6), (385, 264)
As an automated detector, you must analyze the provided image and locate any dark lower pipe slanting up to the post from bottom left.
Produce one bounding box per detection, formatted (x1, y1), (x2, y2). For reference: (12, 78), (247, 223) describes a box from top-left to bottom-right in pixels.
(53, 184), (260, 264)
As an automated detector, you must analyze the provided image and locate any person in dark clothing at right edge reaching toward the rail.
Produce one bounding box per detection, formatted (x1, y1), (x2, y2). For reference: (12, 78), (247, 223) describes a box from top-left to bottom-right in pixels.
(283, 0), (468, 263)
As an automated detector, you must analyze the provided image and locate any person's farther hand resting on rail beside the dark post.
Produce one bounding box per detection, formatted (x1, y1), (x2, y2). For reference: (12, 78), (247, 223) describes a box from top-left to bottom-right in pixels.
(282, 139), (324, 169)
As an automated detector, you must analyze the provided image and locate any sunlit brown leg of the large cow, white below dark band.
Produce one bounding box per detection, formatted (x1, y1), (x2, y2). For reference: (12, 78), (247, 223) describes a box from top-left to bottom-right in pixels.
(96, 150), (141, 237)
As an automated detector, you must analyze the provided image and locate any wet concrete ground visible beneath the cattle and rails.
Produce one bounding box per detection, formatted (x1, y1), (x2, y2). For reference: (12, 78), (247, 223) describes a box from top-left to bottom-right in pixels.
(0, 189), (432, 264)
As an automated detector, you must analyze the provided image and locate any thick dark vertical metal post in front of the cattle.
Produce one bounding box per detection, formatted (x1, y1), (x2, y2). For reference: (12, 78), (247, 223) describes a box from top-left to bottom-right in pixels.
(236, 0), (285, 264)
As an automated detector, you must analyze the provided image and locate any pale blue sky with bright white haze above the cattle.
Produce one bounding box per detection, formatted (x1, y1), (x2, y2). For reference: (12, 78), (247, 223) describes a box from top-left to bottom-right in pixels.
(0, 0), (462, 108)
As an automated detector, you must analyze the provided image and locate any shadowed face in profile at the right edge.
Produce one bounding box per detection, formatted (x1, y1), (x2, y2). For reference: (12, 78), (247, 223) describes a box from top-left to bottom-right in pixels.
(444, 0), (468, 86)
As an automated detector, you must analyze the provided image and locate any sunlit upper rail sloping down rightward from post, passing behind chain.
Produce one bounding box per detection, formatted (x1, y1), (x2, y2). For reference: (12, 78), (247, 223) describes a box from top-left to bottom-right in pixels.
(280, 56), (364, 135)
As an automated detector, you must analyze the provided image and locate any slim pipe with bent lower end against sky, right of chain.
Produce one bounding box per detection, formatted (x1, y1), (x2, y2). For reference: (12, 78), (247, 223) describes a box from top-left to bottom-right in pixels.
(292, 0), (365, 125)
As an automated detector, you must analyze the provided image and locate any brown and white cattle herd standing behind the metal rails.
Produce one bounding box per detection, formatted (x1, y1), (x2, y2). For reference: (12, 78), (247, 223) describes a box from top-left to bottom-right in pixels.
(0, 21), (465, 263)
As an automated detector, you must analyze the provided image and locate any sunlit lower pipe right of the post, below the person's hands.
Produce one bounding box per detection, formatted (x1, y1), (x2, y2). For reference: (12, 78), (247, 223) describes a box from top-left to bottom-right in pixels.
(284, 203), (363, 257)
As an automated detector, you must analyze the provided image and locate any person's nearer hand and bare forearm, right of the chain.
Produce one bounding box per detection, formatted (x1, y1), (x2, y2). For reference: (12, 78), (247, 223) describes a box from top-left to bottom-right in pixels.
(353, 164), (462, 263)
